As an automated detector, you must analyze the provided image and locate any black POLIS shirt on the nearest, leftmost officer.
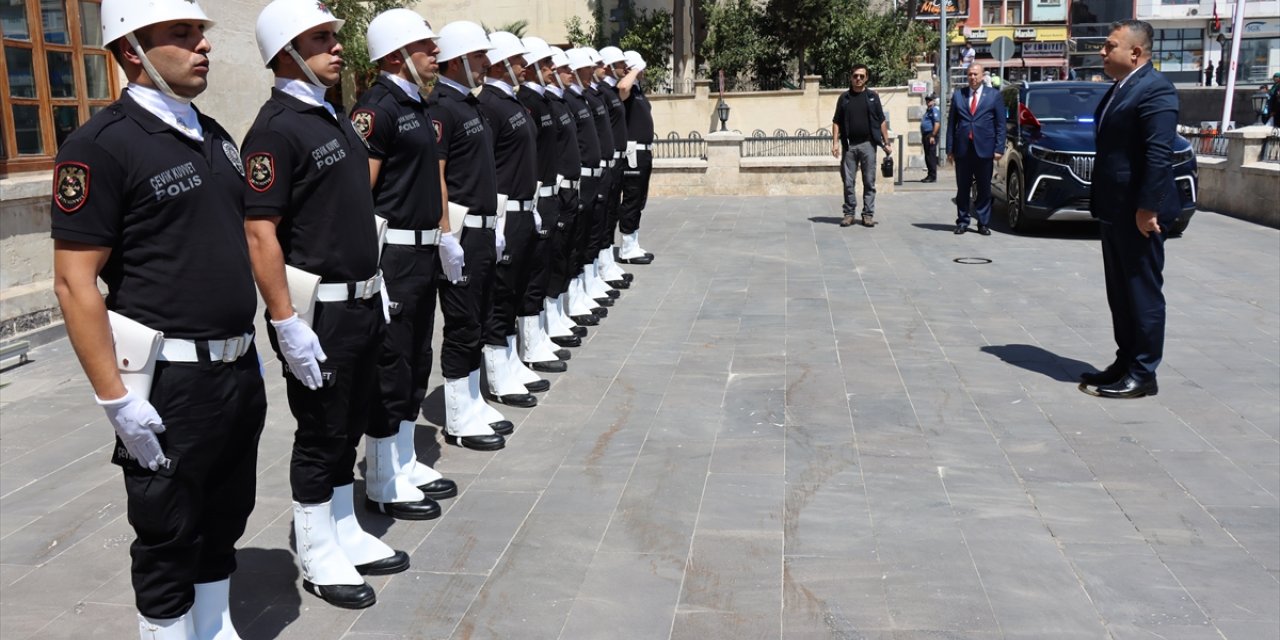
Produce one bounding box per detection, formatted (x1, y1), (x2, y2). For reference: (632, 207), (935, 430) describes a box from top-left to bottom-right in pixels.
(51, 90), (257, 340)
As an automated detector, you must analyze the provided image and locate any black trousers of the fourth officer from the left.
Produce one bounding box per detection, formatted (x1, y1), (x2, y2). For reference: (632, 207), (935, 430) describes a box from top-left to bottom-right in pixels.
(440, 227), (497, 380)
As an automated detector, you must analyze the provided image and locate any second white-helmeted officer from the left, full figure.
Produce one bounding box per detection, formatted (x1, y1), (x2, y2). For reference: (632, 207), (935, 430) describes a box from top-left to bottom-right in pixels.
(243, 0), (408, 608)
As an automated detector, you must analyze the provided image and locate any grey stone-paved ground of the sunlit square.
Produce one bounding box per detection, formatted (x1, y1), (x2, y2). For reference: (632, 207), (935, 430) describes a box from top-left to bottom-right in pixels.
(0, 189), (1280, 640)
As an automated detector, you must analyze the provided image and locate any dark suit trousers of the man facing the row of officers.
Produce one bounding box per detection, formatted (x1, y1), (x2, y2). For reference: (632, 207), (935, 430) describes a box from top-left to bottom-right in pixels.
(1098, 218), (1166, 381)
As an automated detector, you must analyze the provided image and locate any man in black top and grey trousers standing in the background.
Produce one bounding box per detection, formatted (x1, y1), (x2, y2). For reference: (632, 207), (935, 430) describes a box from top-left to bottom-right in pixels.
(831, 64), (891, 227)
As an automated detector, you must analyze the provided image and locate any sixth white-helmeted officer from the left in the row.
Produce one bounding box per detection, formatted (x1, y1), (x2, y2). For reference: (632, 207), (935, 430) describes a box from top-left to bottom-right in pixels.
(516, 36), (581, 372)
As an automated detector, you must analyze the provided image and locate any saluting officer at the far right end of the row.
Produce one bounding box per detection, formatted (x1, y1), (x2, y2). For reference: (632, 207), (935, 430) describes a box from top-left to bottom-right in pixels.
(614, 51), (653, 265)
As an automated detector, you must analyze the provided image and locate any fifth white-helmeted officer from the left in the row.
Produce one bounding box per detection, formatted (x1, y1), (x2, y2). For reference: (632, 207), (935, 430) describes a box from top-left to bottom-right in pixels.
(479, 31), (550, 407)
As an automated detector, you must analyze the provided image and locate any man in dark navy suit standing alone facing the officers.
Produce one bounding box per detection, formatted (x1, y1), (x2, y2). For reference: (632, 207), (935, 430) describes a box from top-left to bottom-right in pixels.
(1080, 20), (1181, 398)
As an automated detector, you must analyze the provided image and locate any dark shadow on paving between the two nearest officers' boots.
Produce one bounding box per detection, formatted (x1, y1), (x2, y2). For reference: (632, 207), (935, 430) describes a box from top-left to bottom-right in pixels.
(230, 545), (302, 639)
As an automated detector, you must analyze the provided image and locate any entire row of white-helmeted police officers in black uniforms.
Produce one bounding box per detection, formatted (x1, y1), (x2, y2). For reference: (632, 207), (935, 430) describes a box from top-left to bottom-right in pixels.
(52, 0), (653, 640)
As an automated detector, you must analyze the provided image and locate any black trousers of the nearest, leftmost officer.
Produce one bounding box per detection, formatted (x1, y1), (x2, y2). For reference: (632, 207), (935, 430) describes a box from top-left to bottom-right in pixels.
(116, 348), (266, 618)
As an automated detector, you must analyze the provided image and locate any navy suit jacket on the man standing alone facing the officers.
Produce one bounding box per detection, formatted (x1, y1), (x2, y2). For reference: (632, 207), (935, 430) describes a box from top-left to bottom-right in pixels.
(1089, 63), (1181, 224)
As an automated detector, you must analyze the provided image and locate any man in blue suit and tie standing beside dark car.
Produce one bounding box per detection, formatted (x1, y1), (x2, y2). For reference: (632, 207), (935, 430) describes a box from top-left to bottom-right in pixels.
(947, 64), (1005, 236)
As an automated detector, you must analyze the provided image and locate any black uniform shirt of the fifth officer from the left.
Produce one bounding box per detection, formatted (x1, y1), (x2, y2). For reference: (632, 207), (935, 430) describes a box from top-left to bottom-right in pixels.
(480, 78), (538, 200)
